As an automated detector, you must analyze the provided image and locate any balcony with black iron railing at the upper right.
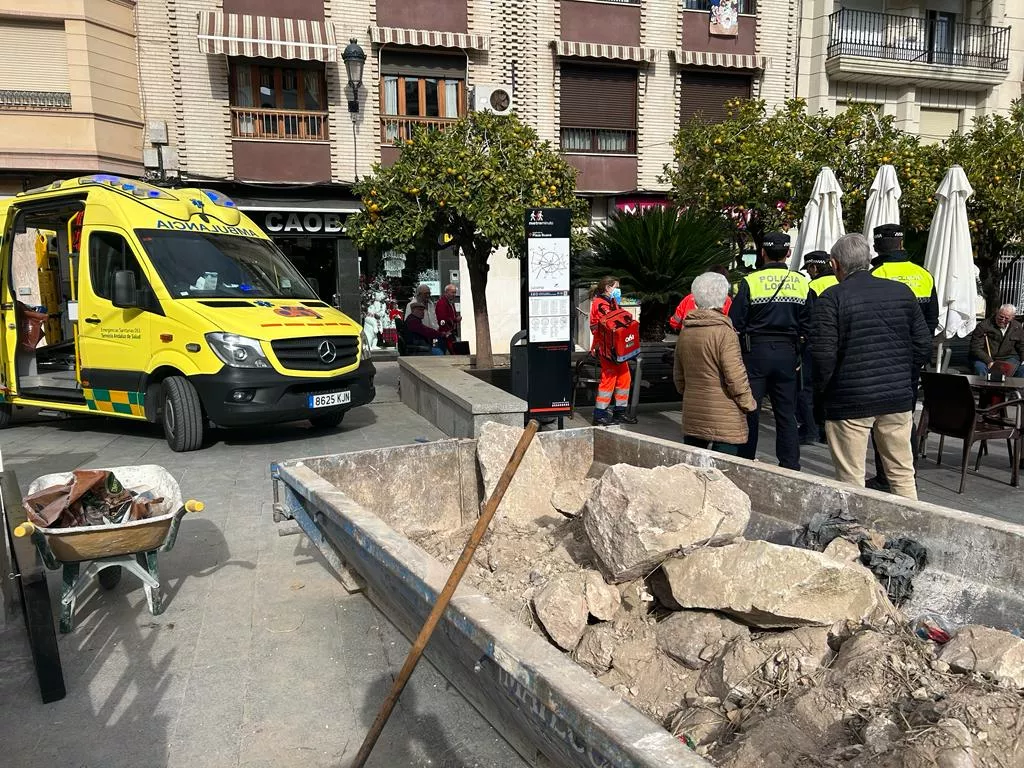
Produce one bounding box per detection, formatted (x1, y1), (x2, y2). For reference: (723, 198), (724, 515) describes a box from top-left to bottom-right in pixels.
(825, 8), (1010, 90)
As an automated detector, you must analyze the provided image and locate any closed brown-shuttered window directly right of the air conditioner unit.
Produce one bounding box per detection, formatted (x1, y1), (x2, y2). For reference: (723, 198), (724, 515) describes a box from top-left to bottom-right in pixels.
(559, 65), (637, 155)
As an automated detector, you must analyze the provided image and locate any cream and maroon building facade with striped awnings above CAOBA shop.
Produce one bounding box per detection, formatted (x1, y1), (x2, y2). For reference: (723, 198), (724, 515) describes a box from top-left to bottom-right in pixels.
(132, 0), (800, 349)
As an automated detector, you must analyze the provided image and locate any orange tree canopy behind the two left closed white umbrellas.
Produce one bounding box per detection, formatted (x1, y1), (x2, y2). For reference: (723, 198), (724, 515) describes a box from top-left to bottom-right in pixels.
(664, 99), (941, 252)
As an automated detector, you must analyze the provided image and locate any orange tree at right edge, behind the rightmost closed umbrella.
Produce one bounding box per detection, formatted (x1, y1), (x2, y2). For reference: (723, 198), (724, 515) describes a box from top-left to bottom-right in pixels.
(947, 101), (1024, 309)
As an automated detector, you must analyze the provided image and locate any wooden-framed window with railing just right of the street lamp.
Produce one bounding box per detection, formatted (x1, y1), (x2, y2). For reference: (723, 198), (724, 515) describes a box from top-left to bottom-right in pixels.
(381, 52), (466, 144)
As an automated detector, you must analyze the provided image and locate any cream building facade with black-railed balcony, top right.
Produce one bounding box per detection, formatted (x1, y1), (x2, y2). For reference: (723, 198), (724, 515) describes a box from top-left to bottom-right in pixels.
(797, 0), (1024, 142)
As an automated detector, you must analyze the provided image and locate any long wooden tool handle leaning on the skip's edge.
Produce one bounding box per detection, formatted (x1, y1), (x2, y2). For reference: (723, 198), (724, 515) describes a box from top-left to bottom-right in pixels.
(351, 419), (540, 768)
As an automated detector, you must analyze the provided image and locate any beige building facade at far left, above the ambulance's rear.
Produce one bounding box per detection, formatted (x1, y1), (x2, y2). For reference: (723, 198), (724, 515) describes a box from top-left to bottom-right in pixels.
(0, 0), (142, 196)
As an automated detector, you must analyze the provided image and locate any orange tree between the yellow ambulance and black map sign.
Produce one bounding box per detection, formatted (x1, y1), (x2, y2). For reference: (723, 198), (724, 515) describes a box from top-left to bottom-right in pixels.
(347, 112), (590, 368)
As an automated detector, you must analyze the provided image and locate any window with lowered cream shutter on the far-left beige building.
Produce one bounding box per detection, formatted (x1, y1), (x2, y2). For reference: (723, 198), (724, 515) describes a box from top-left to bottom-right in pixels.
(0, 18), (71, 110)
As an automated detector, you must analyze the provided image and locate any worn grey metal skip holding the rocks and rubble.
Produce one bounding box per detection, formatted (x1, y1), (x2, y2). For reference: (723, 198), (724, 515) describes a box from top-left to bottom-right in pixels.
(272, 429), (1024, 768)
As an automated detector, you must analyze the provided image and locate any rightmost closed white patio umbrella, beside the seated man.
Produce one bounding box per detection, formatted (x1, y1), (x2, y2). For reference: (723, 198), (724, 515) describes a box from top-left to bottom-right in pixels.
(925, 165), (977, 344)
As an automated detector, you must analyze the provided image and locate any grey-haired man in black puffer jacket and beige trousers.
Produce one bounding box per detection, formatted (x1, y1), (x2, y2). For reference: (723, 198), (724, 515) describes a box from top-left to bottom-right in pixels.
(811, 234), (932, 499)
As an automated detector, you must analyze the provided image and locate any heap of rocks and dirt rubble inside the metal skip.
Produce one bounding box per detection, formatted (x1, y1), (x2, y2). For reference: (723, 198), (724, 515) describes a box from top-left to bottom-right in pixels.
(409, 448), (1024, 768)
